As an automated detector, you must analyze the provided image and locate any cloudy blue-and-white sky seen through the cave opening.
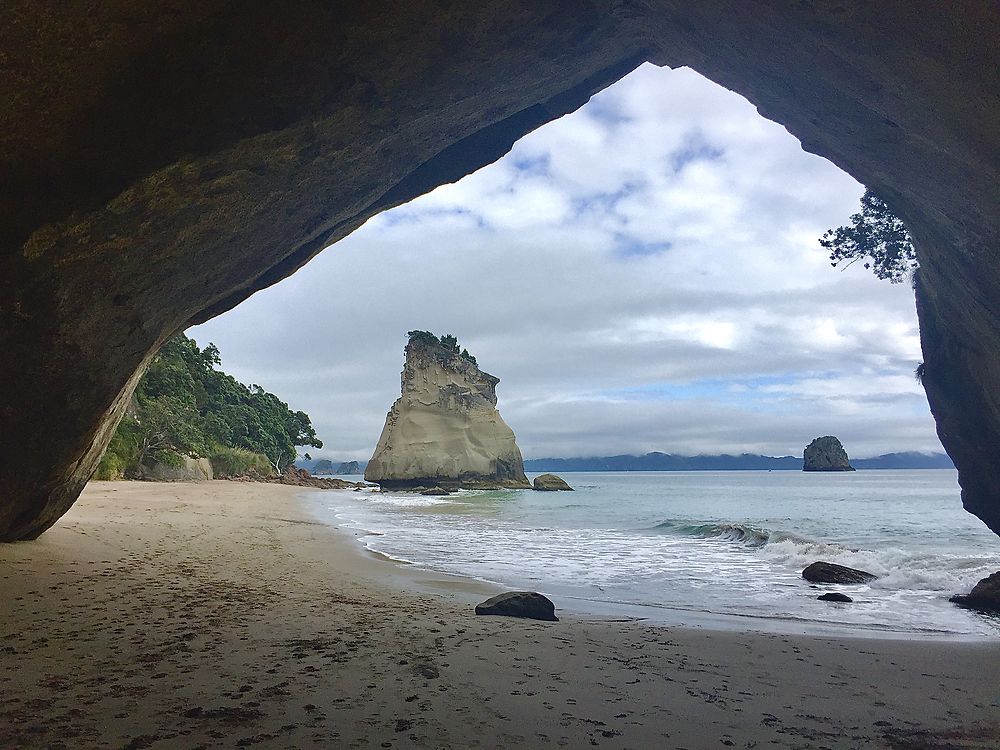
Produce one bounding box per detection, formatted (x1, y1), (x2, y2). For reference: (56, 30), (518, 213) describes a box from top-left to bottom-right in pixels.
(188, 64), (942, 461)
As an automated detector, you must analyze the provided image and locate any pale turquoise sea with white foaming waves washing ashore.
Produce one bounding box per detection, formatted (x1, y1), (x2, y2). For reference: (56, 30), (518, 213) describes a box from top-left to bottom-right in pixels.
(311, 469), (1000, 638)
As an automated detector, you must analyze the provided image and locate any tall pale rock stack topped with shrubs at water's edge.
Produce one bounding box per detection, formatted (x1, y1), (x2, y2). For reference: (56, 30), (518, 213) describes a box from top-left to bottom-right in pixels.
(365, 338), (531, 488)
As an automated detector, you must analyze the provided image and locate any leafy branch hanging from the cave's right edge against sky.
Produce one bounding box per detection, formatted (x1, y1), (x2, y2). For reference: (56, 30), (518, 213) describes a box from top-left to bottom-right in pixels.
(819, 190), (917, 284)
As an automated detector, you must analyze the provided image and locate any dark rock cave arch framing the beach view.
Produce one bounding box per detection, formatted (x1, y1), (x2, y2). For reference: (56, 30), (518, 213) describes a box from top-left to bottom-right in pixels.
(0, 0), (1000, 540)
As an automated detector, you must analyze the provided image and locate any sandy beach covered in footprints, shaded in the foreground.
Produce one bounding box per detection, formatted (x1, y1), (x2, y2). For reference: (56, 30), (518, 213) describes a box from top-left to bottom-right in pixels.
(0, 482), (1000, 750)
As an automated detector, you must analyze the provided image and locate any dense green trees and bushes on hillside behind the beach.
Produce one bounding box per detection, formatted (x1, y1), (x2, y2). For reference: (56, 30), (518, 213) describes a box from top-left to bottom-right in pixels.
(94, 334), (323, 479)
